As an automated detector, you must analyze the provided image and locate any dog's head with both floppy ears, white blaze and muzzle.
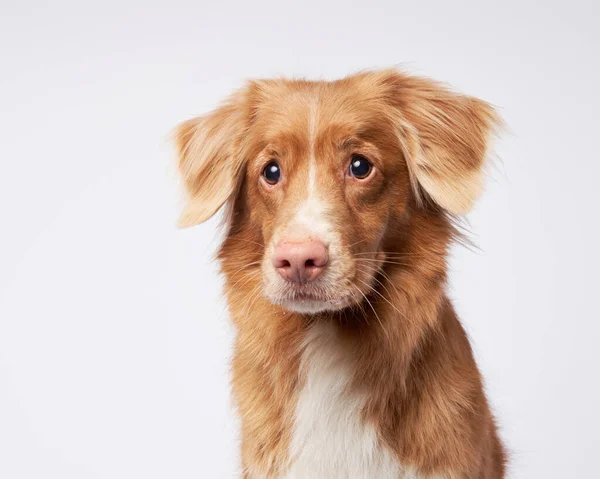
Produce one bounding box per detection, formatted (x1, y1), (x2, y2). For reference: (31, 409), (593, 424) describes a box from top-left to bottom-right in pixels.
(176, 71), (496, 313)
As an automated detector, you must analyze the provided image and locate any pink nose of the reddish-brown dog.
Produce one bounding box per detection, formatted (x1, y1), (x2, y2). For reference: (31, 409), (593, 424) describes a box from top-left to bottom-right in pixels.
(273, 241), (329, 283)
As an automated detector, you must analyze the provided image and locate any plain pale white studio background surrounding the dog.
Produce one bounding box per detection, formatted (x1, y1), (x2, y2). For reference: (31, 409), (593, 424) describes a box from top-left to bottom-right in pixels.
(0, 0), (600, 479)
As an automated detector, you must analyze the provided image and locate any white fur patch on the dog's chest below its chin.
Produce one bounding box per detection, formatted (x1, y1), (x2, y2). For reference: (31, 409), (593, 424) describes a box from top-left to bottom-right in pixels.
(281, 322), (404, 479)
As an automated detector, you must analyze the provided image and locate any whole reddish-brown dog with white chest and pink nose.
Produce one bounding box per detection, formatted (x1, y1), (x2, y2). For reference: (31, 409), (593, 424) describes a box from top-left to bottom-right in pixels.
(175, 70), (506, 479)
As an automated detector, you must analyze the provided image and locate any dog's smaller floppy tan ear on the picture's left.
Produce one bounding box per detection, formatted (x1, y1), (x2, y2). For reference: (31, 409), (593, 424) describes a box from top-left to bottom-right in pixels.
(175, 91), (246, 228)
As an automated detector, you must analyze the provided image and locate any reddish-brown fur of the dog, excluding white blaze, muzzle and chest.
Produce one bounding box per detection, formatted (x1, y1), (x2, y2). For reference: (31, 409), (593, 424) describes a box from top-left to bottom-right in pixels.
(179, 71), (505, 479)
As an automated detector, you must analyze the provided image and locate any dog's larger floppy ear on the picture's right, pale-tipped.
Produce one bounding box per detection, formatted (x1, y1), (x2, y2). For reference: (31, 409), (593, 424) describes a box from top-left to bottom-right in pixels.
(385, 72), (499, 214)
